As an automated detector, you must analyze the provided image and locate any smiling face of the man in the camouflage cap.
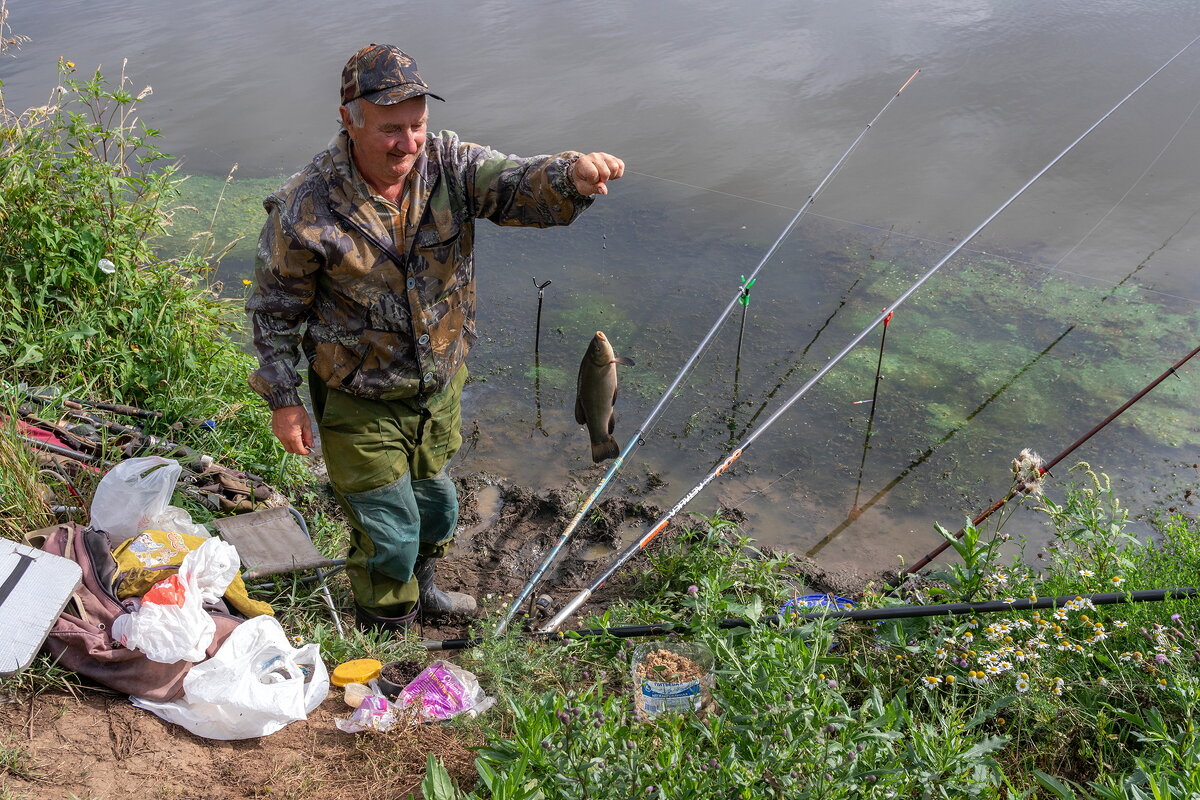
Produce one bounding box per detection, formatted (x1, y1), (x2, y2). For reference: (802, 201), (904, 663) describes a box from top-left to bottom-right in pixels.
(341, 95), (428, 191)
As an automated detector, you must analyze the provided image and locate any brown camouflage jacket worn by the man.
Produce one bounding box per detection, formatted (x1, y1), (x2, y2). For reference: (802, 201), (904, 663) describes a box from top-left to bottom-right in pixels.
(246, 131), (592, 409)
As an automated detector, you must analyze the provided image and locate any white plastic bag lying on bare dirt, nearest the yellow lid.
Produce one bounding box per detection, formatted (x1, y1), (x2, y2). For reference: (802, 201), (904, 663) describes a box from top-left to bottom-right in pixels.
(131, 616), (329, 740)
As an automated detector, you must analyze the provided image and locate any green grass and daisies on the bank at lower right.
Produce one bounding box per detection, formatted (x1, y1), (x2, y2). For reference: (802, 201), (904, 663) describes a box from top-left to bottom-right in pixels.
(436, 465), (1200, 800)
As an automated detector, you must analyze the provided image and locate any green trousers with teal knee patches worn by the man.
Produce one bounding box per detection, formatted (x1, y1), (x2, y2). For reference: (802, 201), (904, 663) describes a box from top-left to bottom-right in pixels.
(308, 365), (467, 616)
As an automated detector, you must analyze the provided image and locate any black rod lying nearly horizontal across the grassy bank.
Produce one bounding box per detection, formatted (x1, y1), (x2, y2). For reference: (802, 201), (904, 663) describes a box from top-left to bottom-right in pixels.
(421, 587), (1200, 650)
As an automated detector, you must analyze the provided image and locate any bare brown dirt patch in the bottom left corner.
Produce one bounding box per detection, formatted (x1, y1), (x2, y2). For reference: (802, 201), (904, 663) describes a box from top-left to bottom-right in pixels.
(0, 692), (480, 800)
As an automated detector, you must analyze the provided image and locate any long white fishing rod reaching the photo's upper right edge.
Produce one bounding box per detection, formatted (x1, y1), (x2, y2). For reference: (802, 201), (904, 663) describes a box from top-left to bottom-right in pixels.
(542, 36), (1200, 631)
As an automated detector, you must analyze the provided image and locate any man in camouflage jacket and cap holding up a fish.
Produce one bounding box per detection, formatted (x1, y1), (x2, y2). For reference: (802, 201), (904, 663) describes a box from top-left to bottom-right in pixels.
(246, 44), (624, 631)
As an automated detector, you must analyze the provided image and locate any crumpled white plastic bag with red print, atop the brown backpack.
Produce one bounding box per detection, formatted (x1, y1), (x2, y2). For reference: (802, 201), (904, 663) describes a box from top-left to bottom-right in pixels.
(112, 539), (240, 663)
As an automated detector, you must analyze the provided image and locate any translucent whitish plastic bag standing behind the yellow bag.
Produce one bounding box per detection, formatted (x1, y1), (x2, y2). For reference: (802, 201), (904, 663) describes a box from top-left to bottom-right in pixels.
(88, 456), (184, 547)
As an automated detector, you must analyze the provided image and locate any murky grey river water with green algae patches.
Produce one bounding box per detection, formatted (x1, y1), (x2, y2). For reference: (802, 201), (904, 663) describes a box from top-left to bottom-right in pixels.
(0, 0), (1200, 569)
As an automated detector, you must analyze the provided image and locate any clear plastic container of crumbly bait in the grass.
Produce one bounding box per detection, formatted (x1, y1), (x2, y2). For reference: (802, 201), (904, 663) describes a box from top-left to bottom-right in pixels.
(632, 642), (713, 720)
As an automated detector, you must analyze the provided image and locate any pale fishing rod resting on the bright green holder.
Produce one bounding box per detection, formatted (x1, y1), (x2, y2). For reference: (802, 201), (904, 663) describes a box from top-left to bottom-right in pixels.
(496, 70), (920, 633)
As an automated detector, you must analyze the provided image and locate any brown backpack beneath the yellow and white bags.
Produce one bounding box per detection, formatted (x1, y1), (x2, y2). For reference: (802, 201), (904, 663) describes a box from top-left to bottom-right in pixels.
(26, 523), (241, 700)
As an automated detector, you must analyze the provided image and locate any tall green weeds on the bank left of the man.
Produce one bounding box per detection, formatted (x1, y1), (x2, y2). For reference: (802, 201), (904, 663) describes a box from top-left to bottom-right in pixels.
(0, 61), (289, 480)
